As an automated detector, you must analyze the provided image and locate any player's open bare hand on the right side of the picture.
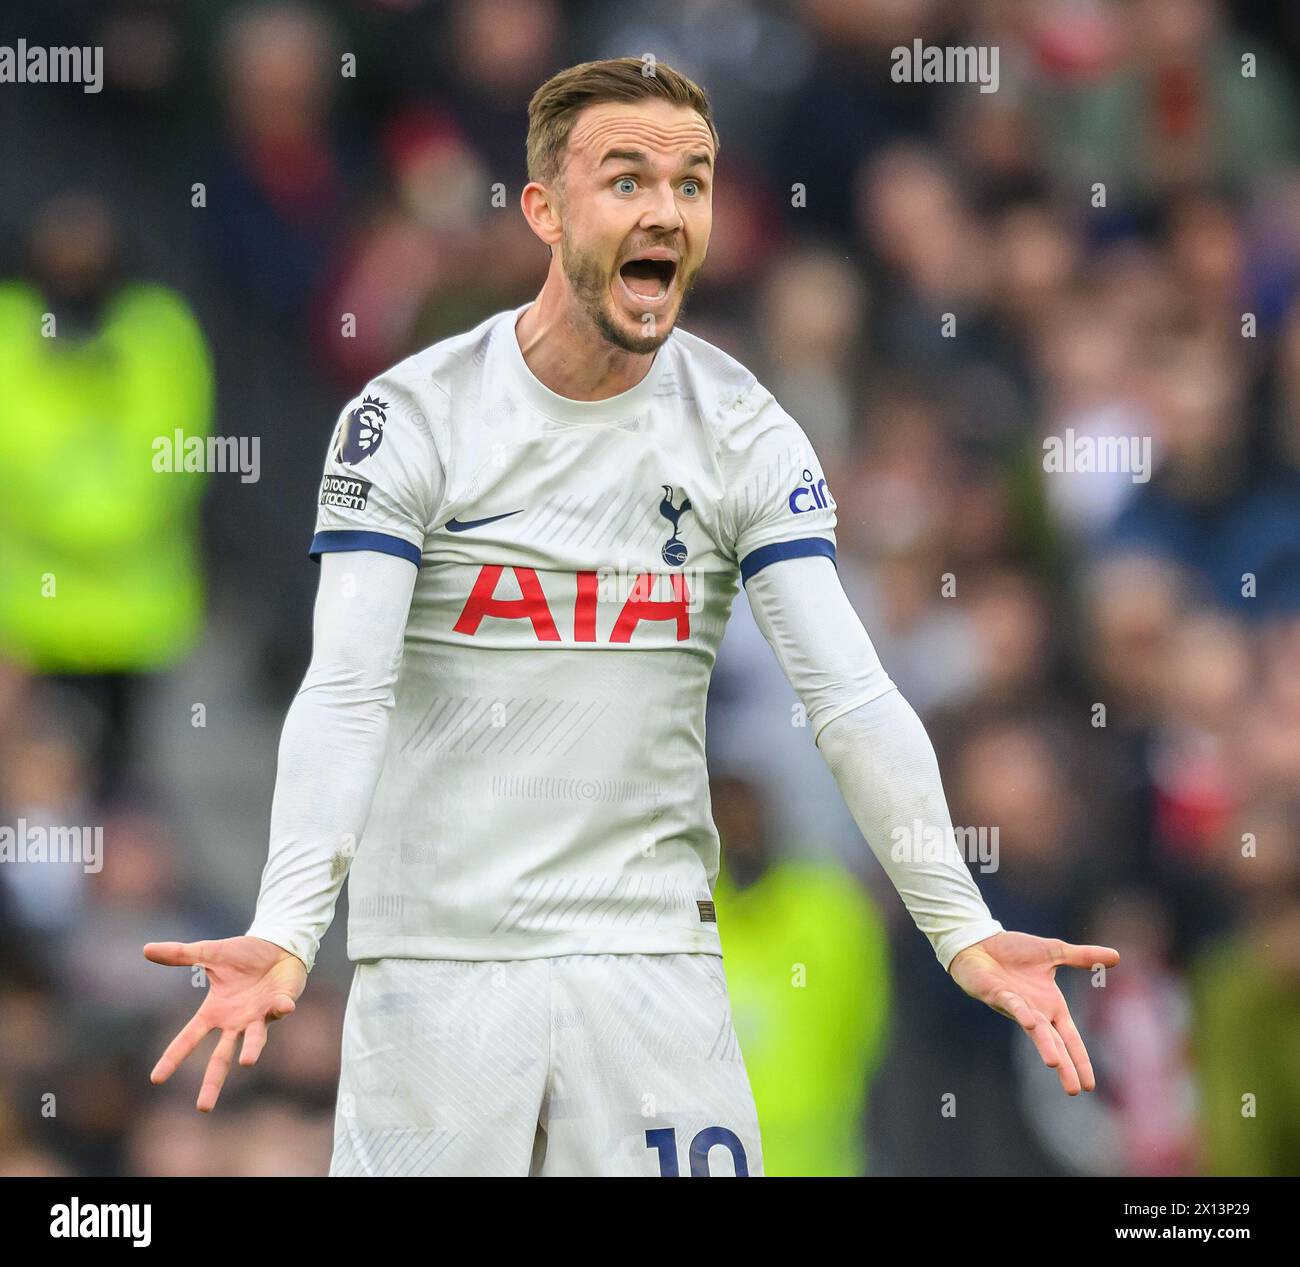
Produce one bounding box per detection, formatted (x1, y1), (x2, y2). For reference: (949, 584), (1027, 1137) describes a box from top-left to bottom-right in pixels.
(948, 933), (1119, 1095)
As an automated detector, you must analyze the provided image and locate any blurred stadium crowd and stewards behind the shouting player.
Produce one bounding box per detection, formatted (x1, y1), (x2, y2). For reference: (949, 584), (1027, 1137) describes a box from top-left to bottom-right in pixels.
(0, 0), (1300, 1175)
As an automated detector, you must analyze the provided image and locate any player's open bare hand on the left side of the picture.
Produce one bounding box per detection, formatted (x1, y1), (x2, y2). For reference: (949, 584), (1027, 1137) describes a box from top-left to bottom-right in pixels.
(144, 937), (307, 1114)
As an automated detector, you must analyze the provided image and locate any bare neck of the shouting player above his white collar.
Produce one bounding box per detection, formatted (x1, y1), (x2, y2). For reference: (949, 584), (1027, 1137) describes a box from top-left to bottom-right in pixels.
(515, 266), (654, 400)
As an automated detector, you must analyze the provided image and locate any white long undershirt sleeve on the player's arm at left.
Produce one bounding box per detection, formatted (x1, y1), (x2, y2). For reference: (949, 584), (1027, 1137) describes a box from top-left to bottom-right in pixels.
(240, 552), (416, 969)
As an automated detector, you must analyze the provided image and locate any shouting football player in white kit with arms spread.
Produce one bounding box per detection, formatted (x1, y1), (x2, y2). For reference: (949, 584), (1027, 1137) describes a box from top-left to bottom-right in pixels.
(144, 57), (1119, 1175)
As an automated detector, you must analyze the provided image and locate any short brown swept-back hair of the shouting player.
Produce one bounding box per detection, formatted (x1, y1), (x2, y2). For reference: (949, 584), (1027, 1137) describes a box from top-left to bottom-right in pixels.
(528, 57), (720, 185)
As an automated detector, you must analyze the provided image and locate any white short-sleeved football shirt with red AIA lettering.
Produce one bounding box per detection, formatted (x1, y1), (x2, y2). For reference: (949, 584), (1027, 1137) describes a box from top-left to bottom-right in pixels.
(312, 304), (835, 959)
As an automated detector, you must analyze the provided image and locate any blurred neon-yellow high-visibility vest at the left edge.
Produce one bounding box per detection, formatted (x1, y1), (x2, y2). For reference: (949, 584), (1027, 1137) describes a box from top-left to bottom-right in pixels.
(0, 282), (212, 672)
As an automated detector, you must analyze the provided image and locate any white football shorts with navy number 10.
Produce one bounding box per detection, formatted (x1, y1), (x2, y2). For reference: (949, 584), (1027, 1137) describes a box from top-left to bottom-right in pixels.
(330, 954), (763, 1176)
